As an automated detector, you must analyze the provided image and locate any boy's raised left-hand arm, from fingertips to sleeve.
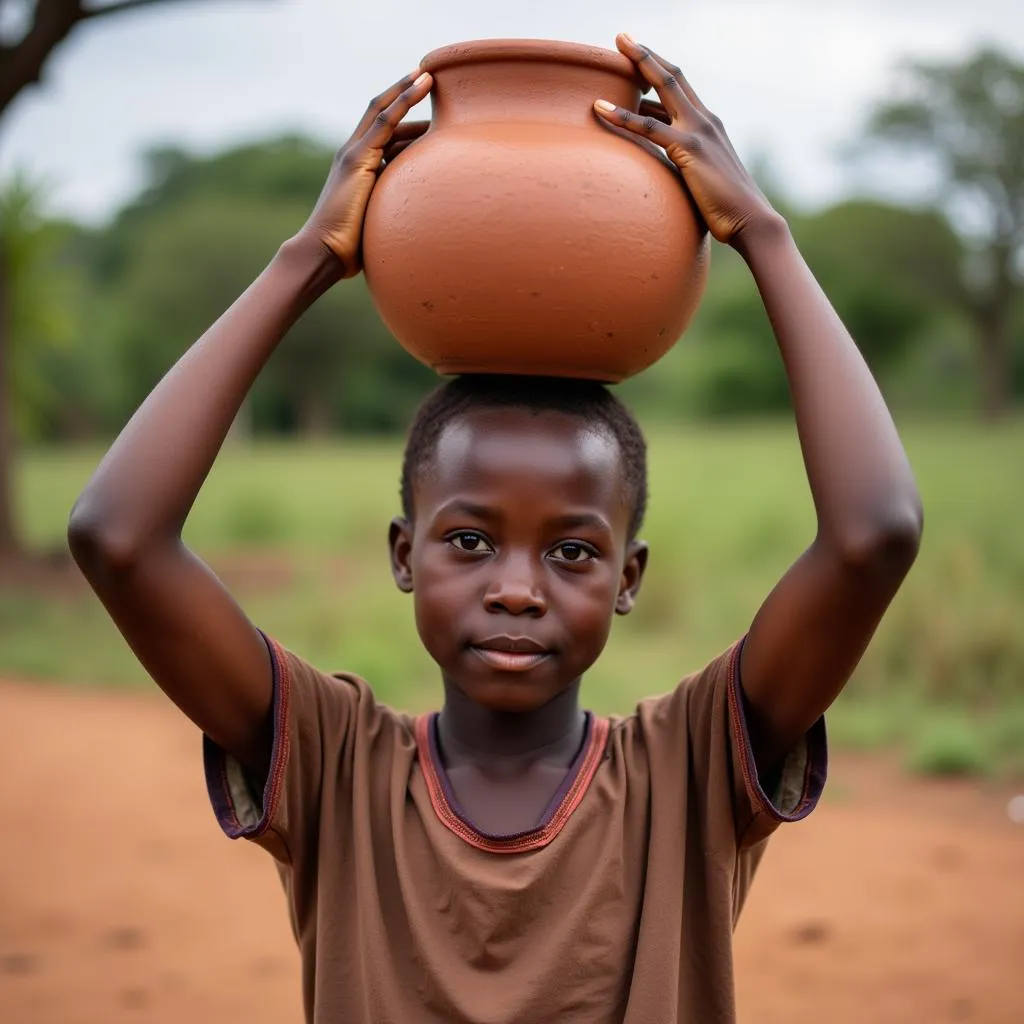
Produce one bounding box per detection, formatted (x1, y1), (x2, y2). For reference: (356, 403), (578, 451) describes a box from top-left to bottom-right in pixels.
(68, 75), (430, 773)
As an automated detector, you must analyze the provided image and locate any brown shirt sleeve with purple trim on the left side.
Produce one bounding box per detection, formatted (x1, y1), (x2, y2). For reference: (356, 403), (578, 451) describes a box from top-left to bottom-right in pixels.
(203, 636), (364, 864)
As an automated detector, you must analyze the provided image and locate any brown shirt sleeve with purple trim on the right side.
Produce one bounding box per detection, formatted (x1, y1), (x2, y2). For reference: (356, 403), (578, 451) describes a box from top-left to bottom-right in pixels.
(641, 640), (827, 850)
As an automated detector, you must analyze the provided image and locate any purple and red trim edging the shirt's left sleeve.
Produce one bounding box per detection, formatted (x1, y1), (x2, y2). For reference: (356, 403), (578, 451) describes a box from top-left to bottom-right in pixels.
(203, 632), (291, 839)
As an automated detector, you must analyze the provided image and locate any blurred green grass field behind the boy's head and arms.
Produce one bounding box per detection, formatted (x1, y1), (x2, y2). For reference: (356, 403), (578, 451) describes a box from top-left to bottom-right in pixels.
(8, 415), (1024, 775)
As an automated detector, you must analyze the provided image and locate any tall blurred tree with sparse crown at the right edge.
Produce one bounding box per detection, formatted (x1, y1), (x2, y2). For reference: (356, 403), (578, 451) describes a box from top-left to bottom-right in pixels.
(867, 49), (1024, 417)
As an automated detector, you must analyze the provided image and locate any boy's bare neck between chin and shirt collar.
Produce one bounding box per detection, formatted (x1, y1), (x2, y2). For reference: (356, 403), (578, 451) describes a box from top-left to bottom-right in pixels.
(437, 679), (587, 767)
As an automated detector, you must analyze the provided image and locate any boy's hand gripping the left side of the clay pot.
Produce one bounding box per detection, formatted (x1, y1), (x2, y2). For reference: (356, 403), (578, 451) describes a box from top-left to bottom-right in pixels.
(299, 73), (433, 280)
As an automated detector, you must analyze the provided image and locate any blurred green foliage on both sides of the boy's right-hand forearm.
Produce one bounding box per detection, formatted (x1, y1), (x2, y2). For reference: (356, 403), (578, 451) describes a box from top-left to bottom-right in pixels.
(626, 200), (963, 418)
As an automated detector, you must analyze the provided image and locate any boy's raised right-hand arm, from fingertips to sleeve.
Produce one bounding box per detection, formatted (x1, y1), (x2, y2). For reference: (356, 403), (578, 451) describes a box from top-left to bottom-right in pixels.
(596, 36), (922, 770)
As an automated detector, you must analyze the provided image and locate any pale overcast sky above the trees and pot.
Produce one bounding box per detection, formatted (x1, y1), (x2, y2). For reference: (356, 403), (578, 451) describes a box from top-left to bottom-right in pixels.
(0, 0), (1024, 220)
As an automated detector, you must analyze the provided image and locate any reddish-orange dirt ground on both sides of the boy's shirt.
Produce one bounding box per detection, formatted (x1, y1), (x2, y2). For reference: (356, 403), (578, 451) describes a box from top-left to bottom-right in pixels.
(0, 683), (1024, 1024)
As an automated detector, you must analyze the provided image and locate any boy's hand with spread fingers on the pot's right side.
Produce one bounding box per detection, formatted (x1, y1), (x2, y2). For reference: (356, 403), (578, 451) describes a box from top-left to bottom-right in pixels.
(594, 34), (778, 245)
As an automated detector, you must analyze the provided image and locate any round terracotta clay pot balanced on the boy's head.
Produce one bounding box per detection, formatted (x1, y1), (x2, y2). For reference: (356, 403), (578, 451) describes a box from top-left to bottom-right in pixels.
(364, 39), (708, 382)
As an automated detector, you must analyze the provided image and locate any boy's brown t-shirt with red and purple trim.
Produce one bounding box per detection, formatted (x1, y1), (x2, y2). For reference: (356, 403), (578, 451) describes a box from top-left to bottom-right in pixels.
(205, 641), (825, 1024)
